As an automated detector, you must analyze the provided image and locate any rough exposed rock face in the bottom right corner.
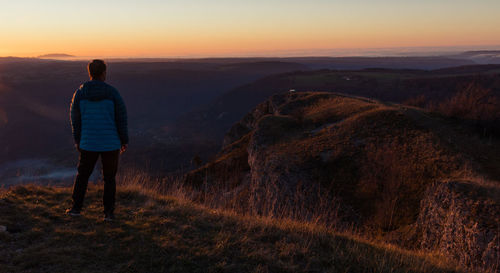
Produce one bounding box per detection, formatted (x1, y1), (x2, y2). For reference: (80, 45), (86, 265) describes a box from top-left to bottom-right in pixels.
(417, 181), (500, 272)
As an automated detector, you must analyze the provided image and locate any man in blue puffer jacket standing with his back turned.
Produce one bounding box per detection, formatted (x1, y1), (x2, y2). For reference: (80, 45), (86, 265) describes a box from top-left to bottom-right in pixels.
(66, 60), (128, 221)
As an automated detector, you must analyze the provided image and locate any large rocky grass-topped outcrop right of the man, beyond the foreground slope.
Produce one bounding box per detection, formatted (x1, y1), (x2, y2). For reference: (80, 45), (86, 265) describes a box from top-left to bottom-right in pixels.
(184, 92), (500, 272)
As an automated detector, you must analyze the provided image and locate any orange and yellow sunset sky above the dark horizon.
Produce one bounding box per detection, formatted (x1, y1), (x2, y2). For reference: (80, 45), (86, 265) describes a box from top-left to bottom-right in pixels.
(0, 0), (500, 57)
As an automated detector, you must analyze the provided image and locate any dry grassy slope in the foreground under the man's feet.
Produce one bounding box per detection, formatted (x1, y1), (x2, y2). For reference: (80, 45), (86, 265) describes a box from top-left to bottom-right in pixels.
(0, 186), (464, 272)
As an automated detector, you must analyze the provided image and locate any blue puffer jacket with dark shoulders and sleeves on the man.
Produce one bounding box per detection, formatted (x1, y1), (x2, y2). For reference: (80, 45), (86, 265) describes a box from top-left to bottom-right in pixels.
(70, 80), (128, 152)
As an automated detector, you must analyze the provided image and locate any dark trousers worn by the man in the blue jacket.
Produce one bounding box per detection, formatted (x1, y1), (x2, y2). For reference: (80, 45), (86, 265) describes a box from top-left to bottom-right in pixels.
(73, 149), (120, 213)
